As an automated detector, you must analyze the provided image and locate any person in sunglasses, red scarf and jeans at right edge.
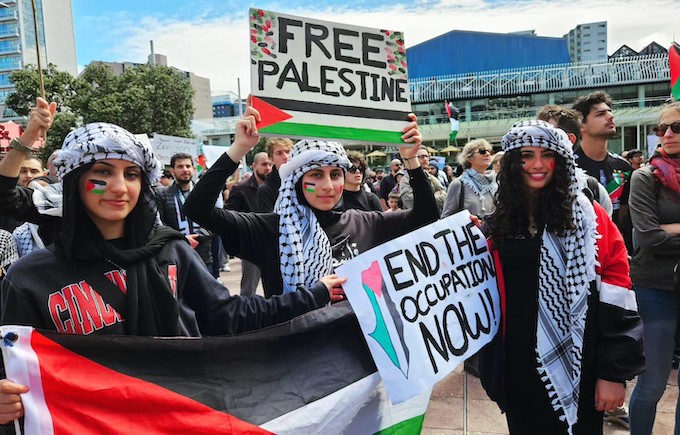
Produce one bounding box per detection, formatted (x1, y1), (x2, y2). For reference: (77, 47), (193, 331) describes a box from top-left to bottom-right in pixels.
(629, 102), (680, 435)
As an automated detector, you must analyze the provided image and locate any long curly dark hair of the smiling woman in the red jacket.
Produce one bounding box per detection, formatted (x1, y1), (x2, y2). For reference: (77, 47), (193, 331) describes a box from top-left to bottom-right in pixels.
(490, 148), (576, 244)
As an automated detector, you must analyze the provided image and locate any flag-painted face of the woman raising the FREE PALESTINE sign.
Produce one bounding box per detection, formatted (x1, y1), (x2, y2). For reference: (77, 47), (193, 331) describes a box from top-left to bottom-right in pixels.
(302, 166), (345, 211)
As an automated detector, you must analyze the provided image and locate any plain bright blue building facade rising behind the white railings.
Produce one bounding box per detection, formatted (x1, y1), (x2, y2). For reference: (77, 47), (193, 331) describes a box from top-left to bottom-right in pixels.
(406, 30), (570, 79)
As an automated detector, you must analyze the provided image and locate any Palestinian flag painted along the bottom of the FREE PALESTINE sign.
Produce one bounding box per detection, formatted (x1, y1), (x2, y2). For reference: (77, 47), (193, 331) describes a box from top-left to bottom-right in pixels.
(251, 96), (410, 144)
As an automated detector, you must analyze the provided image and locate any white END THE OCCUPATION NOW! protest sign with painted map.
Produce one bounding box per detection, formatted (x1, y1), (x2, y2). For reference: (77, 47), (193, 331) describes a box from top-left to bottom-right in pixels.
(336, 210), (500, 404)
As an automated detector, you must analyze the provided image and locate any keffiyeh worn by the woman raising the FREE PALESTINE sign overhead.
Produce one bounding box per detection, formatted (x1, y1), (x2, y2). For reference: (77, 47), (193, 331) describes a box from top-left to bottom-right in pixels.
(274, 140), (350, 293)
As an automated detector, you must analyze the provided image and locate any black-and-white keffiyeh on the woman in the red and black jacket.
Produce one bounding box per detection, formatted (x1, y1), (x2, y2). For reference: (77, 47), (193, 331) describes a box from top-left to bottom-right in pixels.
(501, 120), (596, 433)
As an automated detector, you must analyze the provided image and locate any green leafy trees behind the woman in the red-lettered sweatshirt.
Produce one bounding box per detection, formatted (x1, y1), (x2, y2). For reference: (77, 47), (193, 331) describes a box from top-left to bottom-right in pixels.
(7, 62), (194, 139)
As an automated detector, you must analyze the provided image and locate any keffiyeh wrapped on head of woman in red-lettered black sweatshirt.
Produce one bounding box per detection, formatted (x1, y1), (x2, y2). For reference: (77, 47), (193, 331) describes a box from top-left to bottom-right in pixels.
(54, 122), (161, 184)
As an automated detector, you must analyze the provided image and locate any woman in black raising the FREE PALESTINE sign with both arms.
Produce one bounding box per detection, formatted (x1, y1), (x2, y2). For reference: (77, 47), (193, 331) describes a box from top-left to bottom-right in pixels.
(184, 107), (439, 296)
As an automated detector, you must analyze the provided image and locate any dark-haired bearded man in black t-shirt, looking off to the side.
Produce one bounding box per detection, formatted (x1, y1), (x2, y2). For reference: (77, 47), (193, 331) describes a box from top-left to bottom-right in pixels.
(574, 91), (633, 252)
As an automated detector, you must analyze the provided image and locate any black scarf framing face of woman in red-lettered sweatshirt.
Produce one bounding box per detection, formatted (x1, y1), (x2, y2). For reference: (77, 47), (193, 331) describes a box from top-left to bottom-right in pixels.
(55, 163), (157, 265)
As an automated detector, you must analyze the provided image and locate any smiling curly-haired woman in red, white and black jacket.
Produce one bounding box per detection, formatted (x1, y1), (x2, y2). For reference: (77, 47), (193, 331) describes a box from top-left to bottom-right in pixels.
(480, 120), (644, 435)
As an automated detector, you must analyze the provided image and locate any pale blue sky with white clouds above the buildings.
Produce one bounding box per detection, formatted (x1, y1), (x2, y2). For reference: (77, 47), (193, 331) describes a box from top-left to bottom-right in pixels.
(73, 0), (680, 95)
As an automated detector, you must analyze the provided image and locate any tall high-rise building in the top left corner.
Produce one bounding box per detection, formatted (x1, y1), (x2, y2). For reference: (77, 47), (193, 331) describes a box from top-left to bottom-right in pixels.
(0, 0), (78, 119)
